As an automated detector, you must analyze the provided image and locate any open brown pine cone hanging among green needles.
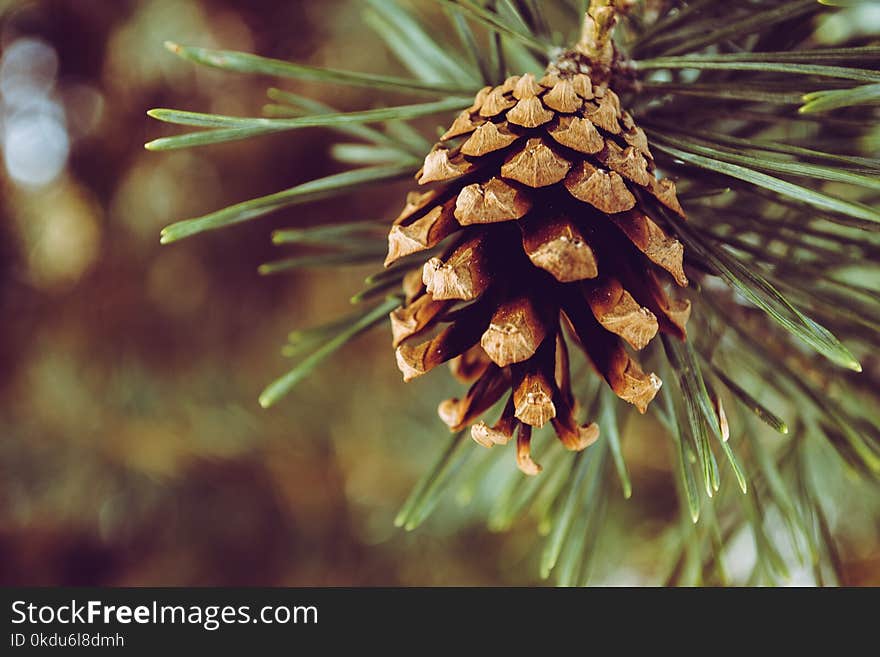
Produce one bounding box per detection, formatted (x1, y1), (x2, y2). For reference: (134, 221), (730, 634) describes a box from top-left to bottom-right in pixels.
(385, 55), (690, 474)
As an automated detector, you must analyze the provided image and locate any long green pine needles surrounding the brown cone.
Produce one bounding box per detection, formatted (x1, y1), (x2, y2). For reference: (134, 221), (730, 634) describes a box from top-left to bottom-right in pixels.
(147, 0), (880, 585)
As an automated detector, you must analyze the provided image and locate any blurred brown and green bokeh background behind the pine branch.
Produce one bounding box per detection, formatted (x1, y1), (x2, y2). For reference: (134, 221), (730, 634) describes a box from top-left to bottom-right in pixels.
(0, 0), (880, 585)
